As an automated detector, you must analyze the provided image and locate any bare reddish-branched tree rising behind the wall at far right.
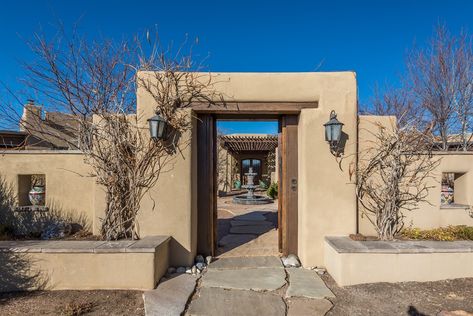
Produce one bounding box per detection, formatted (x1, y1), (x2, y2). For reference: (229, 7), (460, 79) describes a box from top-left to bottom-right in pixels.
(406, 25), (473, 150)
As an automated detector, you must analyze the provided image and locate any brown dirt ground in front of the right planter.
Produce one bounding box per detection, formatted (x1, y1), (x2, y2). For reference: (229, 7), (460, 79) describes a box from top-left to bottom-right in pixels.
(322, 274), (473, 316)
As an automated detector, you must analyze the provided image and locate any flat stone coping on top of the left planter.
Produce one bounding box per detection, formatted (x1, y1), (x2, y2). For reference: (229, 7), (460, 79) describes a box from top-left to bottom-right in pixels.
(0, 236), (171, 253)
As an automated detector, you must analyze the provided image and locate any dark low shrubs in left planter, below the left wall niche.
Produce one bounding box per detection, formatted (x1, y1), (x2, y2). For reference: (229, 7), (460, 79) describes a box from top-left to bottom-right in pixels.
(0, 177), (91, 239)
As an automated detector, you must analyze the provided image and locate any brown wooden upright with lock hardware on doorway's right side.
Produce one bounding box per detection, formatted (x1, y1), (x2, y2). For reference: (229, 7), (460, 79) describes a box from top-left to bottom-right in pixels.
(278, 115), (299, 255)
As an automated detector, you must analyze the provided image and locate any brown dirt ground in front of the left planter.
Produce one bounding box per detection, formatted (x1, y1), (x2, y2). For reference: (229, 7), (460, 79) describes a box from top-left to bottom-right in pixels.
(0, 291), (144, 316)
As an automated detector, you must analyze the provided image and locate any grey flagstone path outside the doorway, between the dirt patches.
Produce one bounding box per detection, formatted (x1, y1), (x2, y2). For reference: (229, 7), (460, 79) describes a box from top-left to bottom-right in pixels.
(144, 256), (334, 316)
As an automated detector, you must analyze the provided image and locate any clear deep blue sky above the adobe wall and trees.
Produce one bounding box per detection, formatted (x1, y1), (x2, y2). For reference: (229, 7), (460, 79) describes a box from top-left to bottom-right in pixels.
(0, 0), (473, 132)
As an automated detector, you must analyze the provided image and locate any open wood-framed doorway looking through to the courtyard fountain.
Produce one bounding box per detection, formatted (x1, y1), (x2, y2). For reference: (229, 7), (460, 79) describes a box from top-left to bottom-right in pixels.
(197, 112), (299, 256)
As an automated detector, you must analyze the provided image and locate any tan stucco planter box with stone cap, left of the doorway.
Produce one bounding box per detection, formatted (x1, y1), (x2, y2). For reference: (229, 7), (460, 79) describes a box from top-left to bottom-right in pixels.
(0, 236), (170, 292)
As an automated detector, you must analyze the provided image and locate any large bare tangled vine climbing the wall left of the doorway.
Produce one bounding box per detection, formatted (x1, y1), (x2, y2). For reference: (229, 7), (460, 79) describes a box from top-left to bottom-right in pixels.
(2, 32), (221, 240)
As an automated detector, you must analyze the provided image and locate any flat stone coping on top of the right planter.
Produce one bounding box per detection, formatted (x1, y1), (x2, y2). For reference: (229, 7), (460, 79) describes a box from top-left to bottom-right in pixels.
(325, 236), (473, 254)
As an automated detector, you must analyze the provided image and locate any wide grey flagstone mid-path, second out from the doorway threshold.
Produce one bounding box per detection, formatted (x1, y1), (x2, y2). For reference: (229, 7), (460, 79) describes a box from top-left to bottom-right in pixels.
(202, 268), (286, 291)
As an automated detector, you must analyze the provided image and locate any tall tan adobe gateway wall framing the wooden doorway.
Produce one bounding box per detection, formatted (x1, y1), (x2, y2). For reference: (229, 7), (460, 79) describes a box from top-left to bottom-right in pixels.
(138, 72), (357, 266)
